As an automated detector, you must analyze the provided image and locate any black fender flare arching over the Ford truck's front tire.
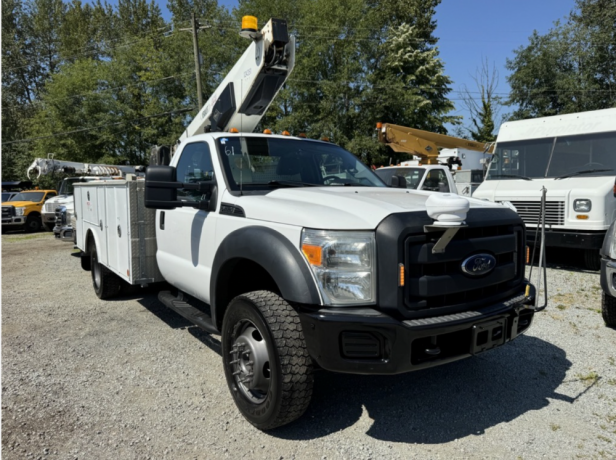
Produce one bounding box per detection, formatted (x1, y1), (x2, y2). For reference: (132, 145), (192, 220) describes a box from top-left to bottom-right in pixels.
(210, 226), (321, 324)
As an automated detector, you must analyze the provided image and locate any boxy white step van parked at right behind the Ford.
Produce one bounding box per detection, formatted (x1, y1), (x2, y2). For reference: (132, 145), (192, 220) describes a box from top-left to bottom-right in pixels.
(473, 108), (616, 270)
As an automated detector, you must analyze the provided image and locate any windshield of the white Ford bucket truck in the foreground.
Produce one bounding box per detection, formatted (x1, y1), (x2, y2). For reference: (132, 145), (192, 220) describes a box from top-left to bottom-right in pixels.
(216, 137), (385, 191)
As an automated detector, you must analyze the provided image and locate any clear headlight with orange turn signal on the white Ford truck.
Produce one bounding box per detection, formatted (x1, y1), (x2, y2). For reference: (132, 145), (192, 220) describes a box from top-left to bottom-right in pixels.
(301, 229), (376, 306)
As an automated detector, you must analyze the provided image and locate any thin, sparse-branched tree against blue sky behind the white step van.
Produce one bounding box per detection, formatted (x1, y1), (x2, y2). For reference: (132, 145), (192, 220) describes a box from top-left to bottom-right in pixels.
(462, 59), (501, 142)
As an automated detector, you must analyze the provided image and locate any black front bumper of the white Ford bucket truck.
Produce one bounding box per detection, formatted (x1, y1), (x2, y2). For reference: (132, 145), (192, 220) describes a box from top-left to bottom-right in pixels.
(299, 289), (534, 374)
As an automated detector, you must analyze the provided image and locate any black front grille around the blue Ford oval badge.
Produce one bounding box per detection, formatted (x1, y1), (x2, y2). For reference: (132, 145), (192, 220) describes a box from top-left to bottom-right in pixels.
(405, 225), (524, 311)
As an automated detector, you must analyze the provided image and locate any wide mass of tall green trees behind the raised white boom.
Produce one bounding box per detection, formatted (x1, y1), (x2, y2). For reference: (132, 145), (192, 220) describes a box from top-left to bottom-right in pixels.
(2, 0), (457, 179)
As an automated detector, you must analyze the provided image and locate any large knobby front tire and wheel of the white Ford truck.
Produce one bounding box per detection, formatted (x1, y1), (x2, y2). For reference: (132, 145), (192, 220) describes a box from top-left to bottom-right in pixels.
(222, 291), (313, 430)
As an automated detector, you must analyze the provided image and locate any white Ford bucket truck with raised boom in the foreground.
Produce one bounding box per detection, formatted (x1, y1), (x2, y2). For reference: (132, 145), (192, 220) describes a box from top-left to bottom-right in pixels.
(75, 16), (535, 429)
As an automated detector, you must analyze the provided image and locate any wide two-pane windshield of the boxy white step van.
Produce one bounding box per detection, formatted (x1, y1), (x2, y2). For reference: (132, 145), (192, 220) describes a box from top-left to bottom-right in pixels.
(486, 132), (616, 180)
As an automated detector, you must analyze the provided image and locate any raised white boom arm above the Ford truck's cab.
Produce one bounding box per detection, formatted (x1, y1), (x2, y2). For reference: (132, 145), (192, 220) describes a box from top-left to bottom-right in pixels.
(179, 19), (295, 142)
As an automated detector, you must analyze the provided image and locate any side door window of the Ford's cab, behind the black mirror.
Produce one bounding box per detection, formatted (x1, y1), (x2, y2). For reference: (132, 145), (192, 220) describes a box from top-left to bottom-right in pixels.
(177, 142), (214, 201)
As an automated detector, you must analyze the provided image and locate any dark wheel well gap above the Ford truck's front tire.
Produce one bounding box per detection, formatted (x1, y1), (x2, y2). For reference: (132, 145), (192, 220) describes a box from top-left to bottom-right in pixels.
(214, 258), (280, 330)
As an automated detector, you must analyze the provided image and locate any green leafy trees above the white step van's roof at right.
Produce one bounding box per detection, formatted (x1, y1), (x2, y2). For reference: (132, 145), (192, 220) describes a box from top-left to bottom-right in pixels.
(507, 0), (616, 119)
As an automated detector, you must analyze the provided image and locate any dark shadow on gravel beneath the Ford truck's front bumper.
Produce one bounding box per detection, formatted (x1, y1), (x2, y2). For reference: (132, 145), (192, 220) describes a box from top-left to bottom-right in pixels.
(269, 336), (579, 444)
